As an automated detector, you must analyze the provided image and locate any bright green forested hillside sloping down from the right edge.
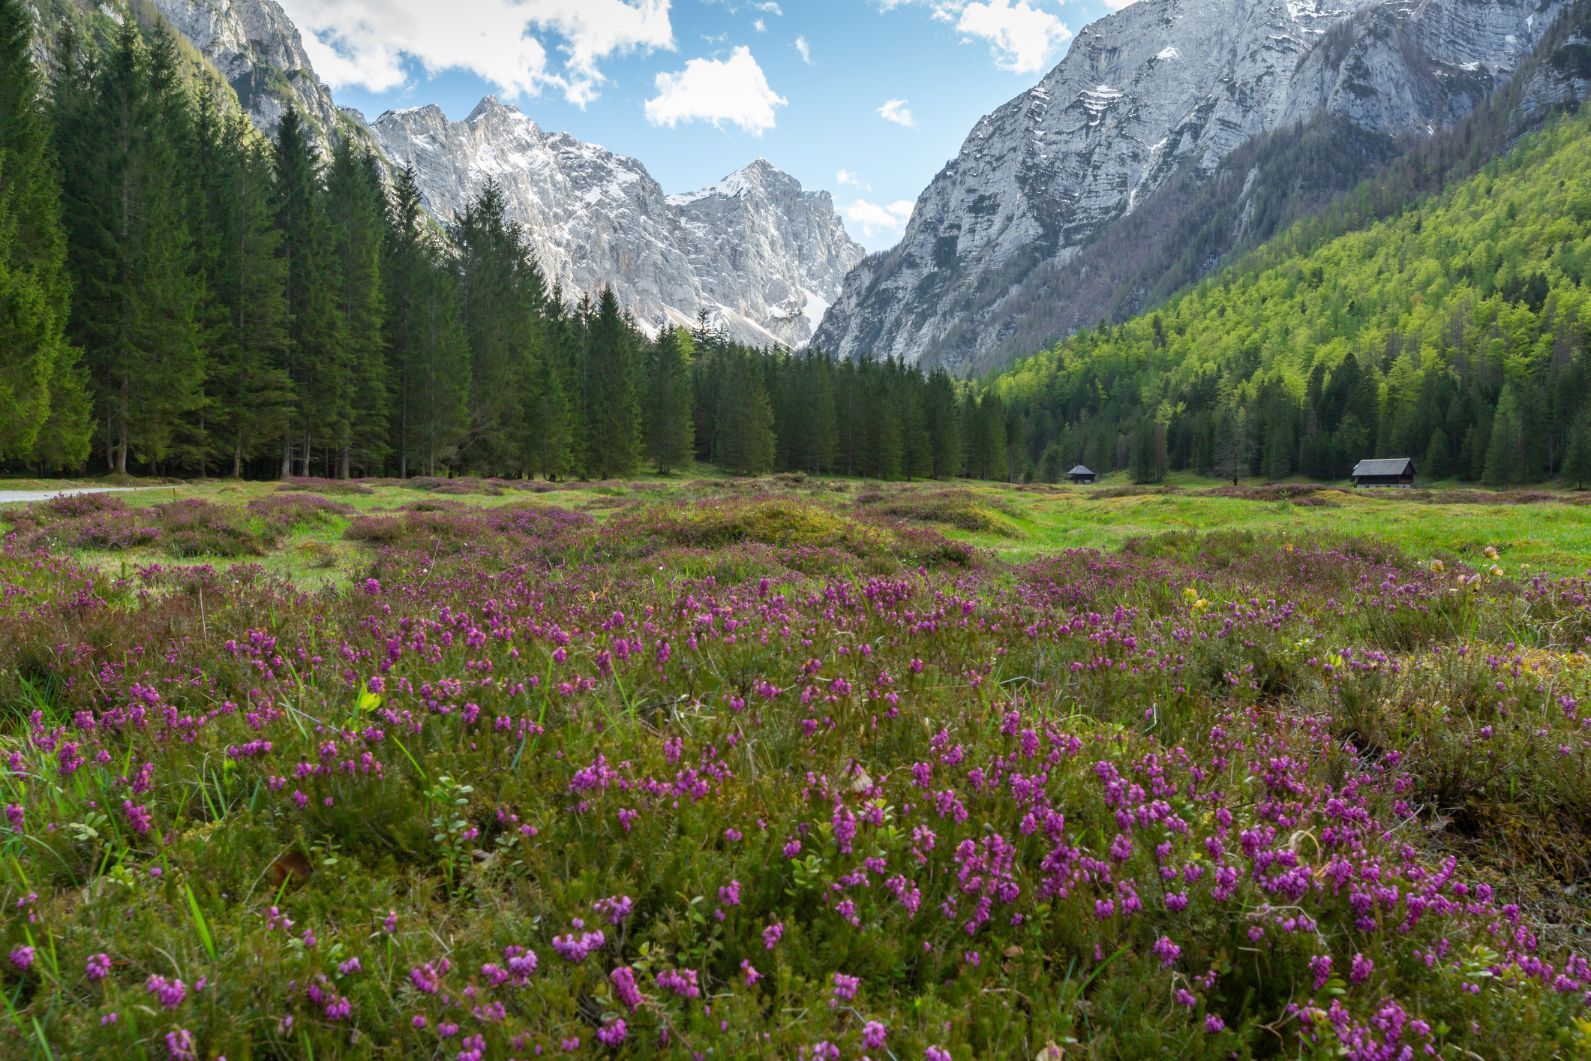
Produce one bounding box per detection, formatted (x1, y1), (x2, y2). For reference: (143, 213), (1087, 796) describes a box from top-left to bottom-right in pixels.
(993, 103), (1591, 484)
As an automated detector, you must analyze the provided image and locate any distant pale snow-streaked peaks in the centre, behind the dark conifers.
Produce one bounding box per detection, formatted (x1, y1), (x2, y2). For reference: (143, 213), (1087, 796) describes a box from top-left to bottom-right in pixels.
(371, 97), (862, 347)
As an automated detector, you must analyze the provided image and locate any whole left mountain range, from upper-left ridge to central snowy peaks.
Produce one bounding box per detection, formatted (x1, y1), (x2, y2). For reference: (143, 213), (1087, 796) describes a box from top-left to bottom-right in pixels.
(49, 0), (864, 347)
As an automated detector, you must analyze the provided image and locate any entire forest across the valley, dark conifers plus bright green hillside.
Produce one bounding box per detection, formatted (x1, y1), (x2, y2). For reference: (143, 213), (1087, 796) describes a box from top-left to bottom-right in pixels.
(0, 0), (1591, 485)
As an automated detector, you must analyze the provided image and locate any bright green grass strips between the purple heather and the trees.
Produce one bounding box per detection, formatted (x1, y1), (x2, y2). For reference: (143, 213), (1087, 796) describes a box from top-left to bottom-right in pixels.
(9, 469), (1591, 584)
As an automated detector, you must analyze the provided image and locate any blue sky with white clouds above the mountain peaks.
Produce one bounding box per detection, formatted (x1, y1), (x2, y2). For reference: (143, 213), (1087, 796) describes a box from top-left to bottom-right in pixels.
(270, 0), (1123, 250)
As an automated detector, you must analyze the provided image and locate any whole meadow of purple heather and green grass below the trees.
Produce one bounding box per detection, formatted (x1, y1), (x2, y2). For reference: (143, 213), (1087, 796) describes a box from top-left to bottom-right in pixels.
(0, 476), (1591, 1061)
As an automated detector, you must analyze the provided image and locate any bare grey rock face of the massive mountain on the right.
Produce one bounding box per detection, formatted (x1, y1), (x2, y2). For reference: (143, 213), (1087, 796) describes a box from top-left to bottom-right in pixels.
(815, 0), (1566, 367)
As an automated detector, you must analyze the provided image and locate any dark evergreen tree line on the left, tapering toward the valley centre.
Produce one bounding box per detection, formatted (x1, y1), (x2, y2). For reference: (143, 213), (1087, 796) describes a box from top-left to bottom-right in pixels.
(0, 0), (980, 479)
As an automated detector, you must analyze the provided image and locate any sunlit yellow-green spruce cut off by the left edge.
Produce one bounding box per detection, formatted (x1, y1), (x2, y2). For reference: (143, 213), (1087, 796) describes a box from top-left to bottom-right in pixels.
(0, 0), (89, 468)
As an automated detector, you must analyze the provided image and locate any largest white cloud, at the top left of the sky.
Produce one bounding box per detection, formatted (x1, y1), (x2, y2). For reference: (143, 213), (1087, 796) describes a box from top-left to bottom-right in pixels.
(282, 0), (675, 107)
